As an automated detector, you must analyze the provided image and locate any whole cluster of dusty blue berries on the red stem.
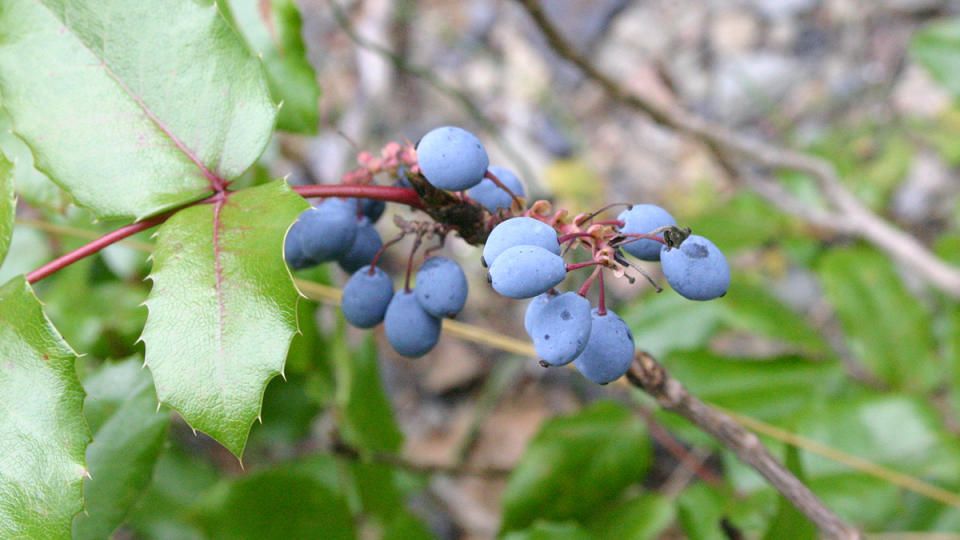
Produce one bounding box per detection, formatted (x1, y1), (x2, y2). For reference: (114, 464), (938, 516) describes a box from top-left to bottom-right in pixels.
(285, 126), (730, 384)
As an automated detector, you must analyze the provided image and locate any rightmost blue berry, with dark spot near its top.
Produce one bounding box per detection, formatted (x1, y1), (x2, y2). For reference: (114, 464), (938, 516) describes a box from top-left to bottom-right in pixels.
(660, 234), (730, 300)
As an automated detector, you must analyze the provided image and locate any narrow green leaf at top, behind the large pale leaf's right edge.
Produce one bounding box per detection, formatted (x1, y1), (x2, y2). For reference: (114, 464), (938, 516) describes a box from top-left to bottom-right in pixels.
(221, 0), (320, 134)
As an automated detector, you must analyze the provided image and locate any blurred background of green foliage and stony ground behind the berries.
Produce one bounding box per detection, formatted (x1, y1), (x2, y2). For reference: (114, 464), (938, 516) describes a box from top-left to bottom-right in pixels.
(0, 0), (960, 540)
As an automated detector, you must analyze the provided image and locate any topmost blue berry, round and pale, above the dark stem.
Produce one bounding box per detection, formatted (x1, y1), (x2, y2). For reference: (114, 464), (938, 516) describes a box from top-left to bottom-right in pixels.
(417, 126), (490, 191)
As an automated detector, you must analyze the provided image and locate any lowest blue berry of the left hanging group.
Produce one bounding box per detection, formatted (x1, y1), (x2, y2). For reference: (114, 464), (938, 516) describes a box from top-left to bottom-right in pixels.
(383, 289), (440, 358)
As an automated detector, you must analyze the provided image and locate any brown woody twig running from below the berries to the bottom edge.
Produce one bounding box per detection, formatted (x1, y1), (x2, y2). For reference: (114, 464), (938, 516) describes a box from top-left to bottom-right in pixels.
(627, 352), (861, 539)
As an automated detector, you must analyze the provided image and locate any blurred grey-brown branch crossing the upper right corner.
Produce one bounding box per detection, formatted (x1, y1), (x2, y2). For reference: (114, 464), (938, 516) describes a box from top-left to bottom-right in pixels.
(517, 0), (960, 298)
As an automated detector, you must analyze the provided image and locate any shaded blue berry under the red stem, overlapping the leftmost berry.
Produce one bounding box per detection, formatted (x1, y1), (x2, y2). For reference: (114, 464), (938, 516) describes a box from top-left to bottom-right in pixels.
(287, 198), (357, 264)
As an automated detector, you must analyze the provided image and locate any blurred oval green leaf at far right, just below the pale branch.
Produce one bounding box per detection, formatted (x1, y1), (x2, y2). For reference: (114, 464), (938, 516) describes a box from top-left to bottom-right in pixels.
(818, 247), (945, 390)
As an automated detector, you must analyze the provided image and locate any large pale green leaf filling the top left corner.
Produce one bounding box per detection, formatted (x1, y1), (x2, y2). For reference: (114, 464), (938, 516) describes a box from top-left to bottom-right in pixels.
(0, 0), (276, 218)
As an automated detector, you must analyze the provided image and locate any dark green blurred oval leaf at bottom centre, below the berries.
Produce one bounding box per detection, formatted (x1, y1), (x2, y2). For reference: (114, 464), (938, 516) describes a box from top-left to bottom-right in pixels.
(502, 401), (650, 532)
